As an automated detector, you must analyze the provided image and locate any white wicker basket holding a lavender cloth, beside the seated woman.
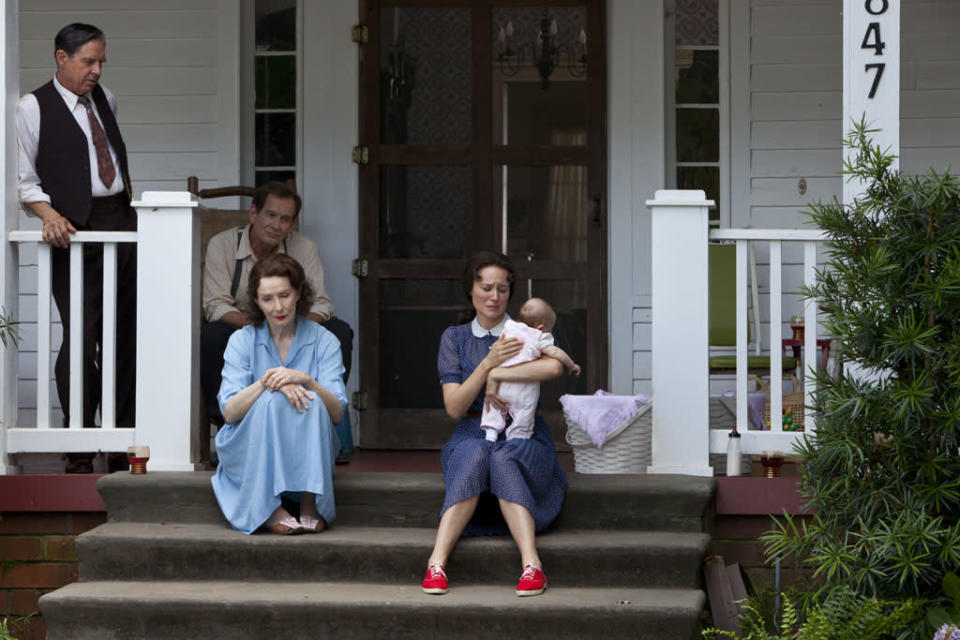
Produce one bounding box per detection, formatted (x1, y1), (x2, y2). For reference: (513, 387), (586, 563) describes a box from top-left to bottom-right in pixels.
(563, 402), (653, 473)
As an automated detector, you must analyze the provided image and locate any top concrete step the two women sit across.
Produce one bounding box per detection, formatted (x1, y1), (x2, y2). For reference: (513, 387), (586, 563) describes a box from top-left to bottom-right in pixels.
(97, 472), (714, 532)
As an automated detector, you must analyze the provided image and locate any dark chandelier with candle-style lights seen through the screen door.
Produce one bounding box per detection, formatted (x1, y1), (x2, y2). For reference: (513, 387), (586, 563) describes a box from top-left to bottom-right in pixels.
(497, 10), (587, 91)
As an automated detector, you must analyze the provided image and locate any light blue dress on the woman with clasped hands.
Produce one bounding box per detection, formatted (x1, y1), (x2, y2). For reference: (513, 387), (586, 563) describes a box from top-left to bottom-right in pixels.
(212, 316), (347, 533)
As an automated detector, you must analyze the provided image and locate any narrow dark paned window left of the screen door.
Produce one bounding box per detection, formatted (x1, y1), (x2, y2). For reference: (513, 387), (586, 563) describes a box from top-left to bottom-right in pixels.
(253, 0), (300, 184)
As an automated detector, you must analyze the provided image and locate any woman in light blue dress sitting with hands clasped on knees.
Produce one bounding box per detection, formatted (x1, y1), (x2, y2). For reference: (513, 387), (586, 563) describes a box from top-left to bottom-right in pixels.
(212, 254), (346, 535)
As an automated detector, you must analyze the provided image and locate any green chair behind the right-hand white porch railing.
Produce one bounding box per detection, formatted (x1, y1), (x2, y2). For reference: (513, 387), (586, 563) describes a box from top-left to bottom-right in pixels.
(708, 244), (798, 387)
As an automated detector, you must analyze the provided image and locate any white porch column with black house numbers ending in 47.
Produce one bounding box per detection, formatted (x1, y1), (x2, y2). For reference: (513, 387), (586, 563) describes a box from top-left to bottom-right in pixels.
(842, 0), (900, 204)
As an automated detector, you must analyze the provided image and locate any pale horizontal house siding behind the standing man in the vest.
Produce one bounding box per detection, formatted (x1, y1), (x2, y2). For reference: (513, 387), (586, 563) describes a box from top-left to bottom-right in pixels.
(17, 0), (239, 426)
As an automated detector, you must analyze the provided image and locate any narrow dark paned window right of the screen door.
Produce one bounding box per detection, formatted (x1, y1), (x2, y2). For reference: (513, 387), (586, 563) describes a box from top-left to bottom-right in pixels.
(666, 0), (729, 225)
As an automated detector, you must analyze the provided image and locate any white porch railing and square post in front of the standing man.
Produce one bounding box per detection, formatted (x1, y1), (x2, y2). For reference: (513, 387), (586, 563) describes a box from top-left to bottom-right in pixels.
(0, 192), (200, 473)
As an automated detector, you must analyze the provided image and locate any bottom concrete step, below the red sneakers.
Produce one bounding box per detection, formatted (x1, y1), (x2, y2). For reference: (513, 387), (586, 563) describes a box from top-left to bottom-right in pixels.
(40, 581), (704, 640)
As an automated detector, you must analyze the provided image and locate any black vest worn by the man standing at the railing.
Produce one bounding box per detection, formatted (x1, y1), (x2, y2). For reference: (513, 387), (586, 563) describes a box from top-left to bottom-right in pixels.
(33, 80), (130, 224)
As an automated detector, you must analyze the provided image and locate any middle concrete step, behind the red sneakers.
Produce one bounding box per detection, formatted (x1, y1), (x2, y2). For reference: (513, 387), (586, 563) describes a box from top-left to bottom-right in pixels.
(77, 522), (710, 588)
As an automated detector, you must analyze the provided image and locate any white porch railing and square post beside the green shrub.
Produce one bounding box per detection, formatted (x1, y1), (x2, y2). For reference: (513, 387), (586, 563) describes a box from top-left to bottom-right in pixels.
(647, 190), (824, 475)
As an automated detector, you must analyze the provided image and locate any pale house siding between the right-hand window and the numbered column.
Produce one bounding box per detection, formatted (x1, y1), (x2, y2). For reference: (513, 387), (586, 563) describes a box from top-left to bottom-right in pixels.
(744, 0), (843, 356)
